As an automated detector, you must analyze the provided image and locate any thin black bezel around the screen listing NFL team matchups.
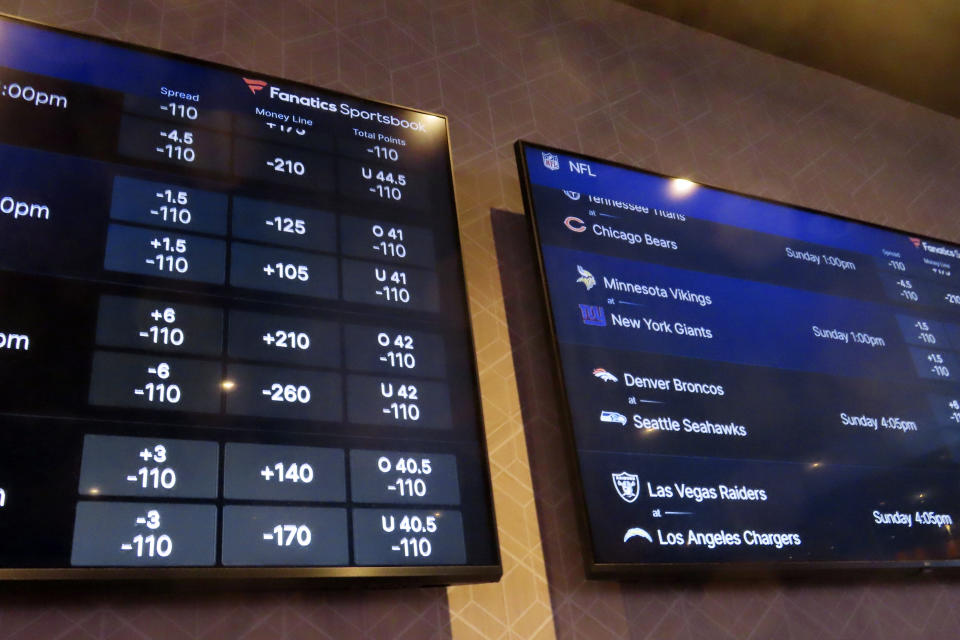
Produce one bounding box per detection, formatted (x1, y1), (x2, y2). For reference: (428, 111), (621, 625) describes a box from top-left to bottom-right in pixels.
(514, 140), (960, 580)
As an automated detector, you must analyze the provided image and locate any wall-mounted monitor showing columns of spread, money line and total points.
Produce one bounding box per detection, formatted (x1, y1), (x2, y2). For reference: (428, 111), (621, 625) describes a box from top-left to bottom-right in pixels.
(0, 13), (500, 582)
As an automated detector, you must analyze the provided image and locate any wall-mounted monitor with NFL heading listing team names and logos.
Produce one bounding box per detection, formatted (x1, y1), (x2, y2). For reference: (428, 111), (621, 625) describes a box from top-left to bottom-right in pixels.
(517, 144), (960, 577)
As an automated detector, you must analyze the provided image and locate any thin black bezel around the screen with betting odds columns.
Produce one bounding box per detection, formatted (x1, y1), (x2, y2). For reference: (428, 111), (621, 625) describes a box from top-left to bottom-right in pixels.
(0, 12), (503, 586)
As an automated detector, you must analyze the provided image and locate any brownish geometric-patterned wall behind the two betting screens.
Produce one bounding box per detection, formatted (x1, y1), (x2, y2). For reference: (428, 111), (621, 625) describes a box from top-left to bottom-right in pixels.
(0, 0), (960, 640)
